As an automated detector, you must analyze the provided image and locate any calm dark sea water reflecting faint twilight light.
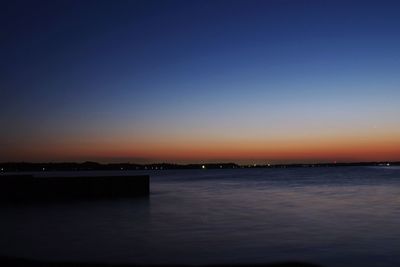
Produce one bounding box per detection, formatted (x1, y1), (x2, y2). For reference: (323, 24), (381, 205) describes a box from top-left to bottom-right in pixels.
(0, 166), (400, 267)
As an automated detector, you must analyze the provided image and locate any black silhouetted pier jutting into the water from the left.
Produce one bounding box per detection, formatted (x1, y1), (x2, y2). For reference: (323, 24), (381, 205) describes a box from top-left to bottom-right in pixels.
(0, 175), (150, 201)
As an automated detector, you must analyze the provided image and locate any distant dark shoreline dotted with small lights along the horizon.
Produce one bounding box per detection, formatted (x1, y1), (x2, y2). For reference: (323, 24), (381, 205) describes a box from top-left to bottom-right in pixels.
(0, 161), (400, 173)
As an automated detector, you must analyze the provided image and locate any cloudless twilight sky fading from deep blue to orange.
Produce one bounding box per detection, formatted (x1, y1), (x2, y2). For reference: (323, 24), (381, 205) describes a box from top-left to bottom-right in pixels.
(0, 0), (400, 163)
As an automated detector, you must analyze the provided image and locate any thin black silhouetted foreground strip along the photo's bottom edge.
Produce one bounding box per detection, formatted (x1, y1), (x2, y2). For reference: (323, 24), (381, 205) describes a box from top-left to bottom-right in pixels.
(0, 257), (320, 267)
